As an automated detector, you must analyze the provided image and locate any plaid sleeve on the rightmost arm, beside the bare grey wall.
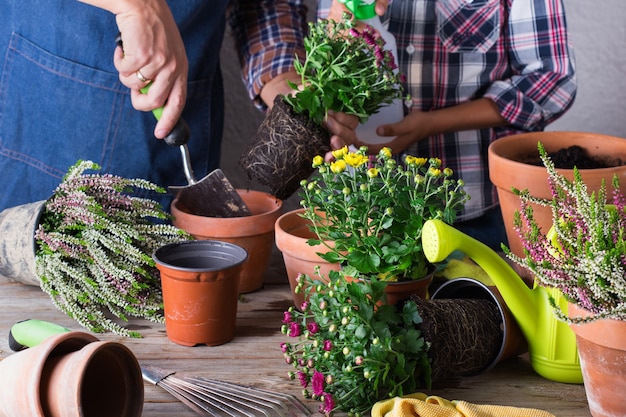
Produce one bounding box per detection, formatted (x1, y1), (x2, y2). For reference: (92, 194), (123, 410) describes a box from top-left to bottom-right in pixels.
(484, 0), (577, 131)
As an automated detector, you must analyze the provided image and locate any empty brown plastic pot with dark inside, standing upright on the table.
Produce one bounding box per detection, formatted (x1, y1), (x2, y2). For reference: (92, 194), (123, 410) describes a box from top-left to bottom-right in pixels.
(153, 240), (247, 346)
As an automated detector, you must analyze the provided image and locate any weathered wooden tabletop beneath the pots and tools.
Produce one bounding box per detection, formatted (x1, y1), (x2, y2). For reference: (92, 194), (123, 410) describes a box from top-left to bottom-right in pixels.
(0, 277), (590, 417)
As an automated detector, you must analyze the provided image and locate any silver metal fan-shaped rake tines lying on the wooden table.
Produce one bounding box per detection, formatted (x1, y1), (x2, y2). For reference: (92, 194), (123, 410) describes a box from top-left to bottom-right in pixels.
(141, 365), (311, 417)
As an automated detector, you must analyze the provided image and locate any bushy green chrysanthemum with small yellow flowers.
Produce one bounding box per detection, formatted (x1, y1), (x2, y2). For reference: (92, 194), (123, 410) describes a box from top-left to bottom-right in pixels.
(300, 147), (469, 281)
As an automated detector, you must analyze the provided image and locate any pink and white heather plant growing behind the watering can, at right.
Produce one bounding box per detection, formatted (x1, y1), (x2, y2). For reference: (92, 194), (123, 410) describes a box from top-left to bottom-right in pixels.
(503, 143), (626, 323)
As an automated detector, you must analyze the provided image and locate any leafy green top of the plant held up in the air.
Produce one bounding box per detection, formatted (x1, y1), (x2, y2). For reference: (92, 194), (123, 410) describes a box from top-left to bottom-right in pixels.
(285, 14), (402, 125)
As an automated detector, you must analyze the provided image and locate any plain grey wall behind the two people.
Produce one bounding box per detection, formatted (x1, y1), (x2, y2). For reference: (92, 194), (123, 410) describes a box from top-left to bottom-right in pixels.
(222, 0), (626, 282)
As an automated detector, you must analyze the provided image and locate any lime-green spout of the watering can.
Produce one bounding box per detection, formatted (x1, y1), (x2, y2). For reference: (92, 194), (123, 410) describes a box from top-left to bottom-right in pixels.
(422, 220), (540, 335)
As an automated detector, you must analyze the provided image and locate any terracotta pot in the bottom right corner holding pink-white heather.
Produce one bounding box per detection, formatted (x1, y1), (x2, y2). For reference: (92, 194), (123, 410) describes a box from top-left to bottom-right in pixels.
(568, 304), (626, 417)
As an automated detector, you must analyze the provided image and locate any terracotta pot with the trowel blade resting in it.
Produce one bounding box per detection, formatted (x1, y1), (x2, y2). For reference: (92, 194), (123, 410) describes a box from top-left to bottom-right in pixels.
(171, 190), (283, 293)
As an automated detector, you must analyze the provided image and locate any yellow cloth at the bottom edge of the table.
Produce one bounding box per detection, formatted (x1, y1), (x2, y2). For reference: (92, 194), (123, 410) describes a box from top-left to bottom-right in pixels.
(372, 392), (554, 417)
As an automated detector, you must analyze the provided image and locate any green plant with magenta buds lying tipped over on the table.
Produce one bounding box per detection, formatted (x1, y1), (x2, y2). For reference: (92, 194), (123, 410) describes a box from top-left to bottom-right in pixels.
(281, 271), (431, 417)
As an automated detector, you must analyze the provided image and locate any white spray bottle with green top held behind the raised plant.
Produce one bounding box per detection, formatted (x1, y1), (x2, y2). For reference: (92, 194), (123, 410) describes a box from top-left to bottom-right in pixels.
(339, 0), (404, 144)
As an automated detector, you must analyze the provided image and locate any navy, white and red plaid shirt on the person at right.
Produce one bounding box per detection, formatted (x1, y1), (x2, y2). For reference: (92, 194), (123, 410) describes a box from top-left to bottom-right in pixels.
(318, 0), (576, 220)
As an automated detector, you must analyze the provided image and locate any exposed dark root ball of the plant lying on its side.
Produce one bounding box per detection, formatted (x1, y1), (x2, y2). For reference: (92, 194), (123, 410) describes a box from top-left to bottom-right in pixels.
(408, 296), (504, 382)
